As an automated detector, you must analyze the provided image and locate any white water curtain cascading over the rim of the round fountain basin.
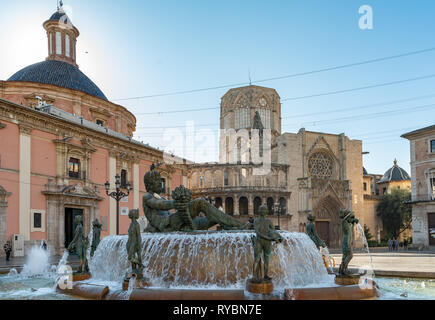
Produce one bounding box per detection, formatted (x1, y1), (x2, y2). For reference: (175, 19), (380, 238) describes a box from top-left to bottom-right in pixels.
(89, 231), (331, 288)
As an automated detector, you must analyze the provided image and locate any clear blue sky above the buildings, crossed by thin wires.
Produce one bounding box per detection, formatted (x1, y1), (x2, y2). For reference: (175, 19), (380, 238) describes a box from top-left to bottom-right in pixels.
(0, 0), (435, 173)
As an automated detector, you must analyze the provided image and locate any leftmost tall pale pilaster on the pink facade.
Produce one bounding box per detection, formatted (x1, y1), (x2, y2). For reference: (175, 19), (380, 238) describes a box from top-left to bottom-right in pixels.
(18, 124), (32, 241)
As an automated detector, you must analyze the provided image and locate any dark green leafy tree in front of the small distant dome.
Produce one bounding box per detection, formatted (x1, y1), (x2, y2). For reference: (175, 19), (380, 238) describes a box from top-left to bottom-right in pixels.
(376, 188), (412, 238)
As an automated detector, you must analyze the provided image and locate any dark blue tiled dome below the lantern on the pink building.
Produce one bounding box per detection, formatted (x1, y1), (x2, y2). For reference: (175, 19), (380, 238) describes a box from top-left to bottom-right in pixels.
(7, 60), (107, 100)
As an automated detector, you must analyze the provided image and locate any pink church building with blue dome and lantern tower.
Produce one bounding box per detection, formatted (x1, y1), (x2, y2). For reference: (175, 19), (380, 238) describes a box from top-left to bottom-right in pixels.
(0, 8), (186, 253)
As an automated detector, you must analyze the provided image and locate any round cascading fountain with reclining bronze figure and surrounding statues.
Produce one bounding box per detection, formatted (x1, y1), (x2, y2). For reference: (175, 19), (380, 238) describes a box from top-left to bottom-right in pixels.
(14, 170), (377, 300)
